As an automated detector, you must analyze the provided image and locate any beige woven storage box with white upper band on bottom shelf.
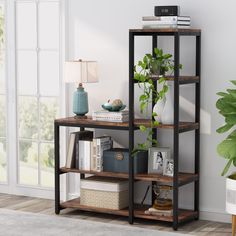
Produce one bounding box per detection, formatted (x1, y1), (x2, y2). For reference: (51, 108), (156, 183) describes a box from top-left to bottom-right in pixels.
(80, 176), (128, 210)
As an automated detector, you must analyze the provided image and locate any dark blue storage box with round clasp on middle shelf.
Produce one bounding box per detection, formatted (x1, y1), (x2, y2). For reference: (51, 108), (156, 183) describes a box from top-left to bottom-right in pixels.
(103, 148), (148, 174)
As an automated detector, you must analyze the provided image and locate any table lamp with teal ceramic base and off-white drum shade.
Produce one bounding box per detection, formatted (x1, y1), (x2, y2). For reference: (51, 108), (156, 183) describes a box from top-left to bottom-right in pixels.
(65, 60), (98, 119)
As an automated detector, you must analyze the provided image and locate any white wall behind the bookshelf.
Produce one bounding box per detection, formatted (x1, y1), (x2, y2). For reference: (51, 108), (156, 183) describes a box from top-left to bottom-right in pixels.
(65, 0), (236, 221)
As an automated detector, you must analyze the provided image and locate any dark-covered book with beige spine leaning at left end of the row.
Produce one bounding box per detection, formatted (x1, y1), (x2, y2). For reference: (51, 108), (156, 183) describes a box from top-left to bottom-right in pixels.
(65, 131), (93, 168)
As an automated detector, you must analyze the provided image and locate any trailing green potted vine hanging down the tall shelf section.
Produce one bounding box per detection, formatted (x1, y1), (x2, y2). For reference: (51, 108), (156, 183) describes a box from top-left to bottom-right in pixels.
(134, 48), (182, 150)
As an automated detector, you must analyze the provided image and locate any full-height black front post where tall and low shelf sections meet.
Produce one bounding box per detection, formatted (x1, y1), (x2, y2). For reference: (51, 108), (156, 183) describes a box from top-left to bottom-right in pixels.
(129, 32), (134, 224)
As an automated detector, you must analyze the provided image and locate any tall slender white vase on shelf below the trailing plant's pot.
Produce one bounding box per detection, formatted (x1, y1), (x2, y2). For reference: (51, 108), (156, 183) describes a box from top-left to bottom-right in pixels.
(161, 81), (174, 125)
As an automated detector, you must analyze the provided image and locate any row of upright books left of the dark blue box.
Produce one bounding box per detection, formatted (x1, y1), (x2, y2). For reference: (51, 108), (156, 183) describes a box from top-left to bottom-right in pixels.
(65, 131), (113, 172)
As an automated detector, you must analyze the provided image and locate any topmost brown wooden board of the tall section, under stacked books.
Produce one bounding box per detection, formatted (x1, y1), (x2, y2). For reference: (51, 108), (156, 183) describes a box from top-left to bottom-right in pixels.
(129, 28), (201, 36)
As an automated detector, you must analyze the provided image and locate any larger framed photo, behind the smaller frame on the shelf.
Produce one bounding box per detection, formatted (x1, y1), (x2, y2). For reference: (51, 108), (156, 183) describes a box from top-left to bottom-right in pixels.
(148, 147), (170, 174)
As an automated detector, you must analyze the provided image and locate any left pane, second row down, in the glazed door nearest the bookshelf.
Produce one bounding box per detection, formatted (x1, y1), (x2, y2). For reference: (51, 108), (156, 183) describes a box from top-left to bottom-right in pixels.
(17, 51), (37, 95)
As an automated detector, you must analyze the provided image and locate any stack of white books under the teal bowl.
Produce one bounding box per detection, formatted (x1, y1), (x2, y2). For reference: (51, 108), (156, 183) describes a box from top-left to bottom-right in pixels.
(92, 110), (129, 122)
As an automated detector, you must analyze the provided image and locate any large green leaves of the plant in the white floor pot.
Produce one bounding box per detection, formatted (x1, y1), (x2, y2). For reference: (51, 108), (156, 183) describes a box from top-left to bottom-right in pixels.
(216, 80), (236, 176)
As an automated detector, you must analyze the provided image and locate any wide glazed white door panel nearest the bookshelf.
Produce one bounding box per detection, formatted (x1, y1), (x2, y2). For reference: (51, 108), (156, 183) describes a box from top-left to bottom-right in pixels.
(16, 0), (60, 187)
